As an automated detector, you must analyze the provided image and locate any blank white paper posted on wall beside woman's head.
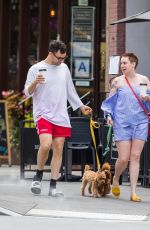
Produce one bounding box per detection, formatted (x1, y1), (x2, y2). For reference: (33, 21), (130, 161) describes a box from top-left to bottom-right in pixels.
(108, 56), (120, 74)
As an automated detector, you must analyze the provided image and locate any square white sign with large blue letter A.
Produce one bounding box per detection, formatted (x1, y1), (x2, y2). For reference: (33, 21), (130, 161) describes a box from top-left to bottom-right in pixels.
(75, 58), (90, 77)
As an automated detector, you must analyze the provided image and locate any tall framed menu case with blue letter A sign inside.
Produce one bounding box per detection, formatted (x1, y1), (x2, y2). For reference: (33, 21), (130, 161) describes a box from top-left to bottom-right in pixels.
(71, 6), (95, 83)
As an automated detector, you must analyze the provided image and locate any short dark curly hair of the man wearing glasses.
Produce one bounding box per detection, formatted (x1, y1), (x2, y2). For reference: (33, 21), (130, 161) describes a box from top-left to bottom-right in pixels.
(49, 40), (67, 54)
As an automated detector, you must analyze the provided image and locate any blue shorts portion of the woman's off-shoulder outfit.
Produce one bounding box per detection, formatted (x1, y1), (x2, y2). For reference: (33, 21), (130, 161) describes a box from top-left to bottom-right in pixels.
(113, 123), (148, 141)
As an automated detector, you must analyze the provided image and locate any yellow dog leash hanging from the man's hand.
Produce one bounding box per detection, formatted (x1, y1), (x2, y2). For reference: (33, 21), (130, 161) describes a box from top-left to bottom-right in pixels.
(90, 114), (101, 171)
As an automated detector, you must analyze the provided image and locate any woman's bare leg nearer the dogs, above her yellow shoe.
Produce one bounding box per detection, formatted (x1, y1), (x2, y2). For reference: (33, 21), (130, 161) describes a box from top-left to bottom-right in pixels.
(113, 140), (131, 186)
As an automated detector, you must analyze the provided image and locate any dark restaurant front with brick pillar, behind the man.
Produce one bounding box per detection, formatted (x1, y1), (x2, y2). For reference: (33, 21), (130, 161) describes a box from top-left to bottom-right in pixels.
(0, 0), (126, 116)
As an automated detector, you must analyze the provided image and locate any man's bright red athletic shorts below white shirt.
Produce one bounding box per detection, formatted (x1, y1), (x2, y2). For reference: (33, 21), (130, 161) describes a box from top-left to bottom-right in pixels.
(37, 118), (71, 137)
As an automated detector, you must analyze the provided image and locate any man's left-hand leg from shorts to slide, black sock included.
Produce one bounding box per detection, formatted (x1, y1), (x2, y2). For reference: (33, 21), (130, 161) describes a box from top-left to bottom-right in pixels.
(31, 134), (52, 194)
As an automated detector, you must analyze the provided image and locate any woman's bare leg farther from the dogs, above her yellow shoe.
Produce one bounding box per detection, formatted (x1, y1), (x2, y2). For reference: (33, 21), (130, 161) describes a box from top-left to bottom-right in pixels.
(129, 140), (145, 196)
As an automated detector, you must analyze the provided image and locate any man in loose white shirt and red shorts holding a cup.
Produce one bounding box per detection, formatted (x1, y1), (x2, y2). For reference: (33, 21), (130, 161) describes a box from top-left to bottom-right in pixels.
(25, 40), (92, 197)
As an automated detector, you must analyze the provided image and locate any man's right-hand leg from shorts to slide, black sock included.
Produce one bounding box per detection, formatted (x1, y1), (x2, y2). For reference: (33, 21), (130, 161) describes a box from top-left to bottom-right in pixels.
(49, 137), (65, 197)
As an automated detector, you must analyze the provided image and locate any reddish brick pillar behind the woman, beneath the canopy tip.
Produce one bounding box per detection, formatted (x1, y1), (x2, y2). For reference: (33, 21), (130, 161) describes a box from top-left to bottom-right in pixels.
(105, 0), (126, 92)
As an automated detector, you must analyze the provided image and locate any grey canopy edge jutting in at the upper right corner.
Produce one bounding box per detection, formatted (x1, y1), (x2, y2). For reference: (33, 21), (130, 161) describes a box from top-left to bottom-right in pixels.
(110, 10), (150, 25)
